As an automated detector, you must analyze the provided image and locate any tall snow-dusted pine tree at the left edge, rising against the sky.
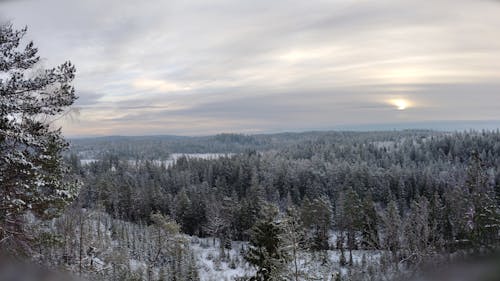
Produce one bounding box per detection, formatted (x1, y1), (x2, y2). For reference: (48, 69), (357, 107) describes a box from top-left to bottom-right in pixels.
(0, 24), (78, 254)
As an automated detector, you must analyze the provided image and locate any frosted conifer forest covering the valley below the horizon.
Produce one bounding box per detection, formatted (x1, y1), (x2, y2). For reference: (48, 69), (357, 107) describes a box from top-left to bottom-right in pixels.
(36, 131), (500, 280)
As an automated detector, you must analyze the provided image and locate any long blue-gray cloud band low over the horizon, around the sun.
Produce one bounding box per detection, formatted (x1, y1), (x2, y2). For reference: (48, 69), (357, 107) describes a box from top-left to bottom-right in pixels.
(78, 80), (500, 133)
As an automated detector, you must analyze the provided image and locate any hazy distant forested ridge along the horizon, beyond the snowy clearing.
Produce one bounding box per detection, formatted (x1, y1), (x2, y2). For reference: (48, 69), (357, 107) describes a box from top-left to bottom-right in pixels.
(70, 131), (442, 160)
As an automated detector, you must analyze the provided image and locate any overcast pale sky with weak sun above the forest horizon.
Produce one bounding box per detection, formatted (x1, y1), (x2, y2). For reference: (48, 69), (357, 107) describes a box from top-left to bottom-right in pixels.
(0, 0), (500, 136)
